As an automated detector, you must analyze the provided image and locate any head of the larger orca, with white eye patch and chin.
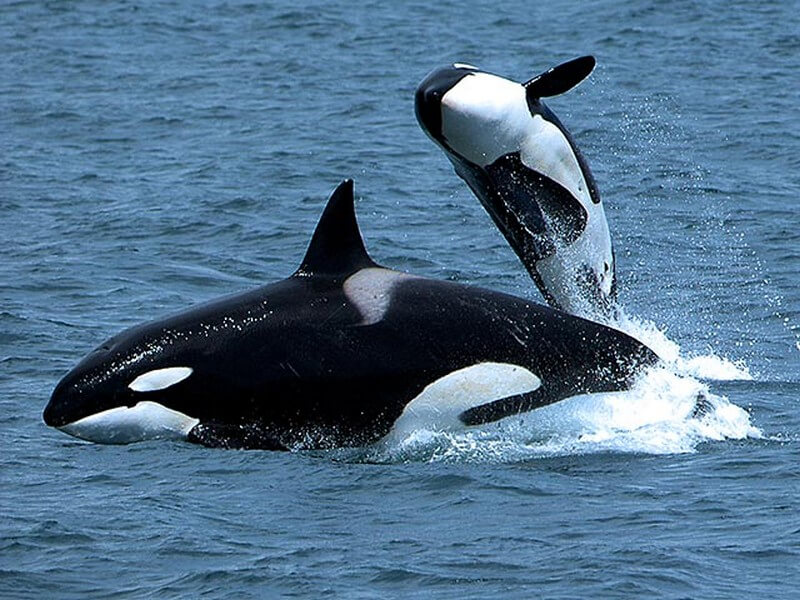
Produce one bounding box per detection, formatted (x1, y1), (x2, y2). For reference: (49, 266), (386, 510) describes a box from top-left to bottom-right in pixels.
(42, 324), (203, 444)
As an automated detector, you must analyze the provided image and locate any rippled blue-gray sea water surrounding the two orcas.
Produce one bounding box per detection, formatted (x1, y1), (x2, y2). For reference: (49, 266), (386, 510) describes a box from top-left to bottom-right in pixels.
(0, 0), (800, 598)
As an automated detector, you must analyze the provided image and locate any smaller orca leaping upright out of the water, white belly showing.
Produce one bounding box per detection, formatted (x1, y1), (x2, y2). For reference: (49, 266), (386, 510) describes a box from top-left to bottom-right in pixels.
(414, 56), (617, 320)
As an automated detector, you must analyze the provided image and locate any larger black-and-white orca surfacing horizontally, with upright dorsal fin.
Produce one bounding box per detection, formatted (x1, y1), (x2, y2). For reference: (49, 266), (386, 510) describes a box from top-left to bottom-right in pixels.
(43, 180), (657, 450)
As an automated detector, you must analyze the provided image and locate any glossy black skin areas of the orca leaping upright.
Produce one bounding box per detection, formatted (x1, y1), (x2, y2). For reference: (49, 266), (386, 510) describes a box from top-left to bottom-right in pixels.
(414, 63), (617, 317)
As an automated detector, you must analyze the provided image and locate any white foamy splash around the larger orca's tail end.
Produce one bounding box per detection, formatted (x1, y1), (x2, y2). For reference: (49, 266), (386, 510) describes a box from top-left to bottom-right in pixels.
(361, 314), (762, 462)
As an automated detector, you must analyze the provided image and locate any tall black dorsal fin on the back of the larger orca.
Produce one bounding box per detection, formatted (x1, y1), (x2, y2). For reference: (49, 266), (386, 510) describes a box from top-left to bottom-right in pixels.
(295, 179), (376, 276)
